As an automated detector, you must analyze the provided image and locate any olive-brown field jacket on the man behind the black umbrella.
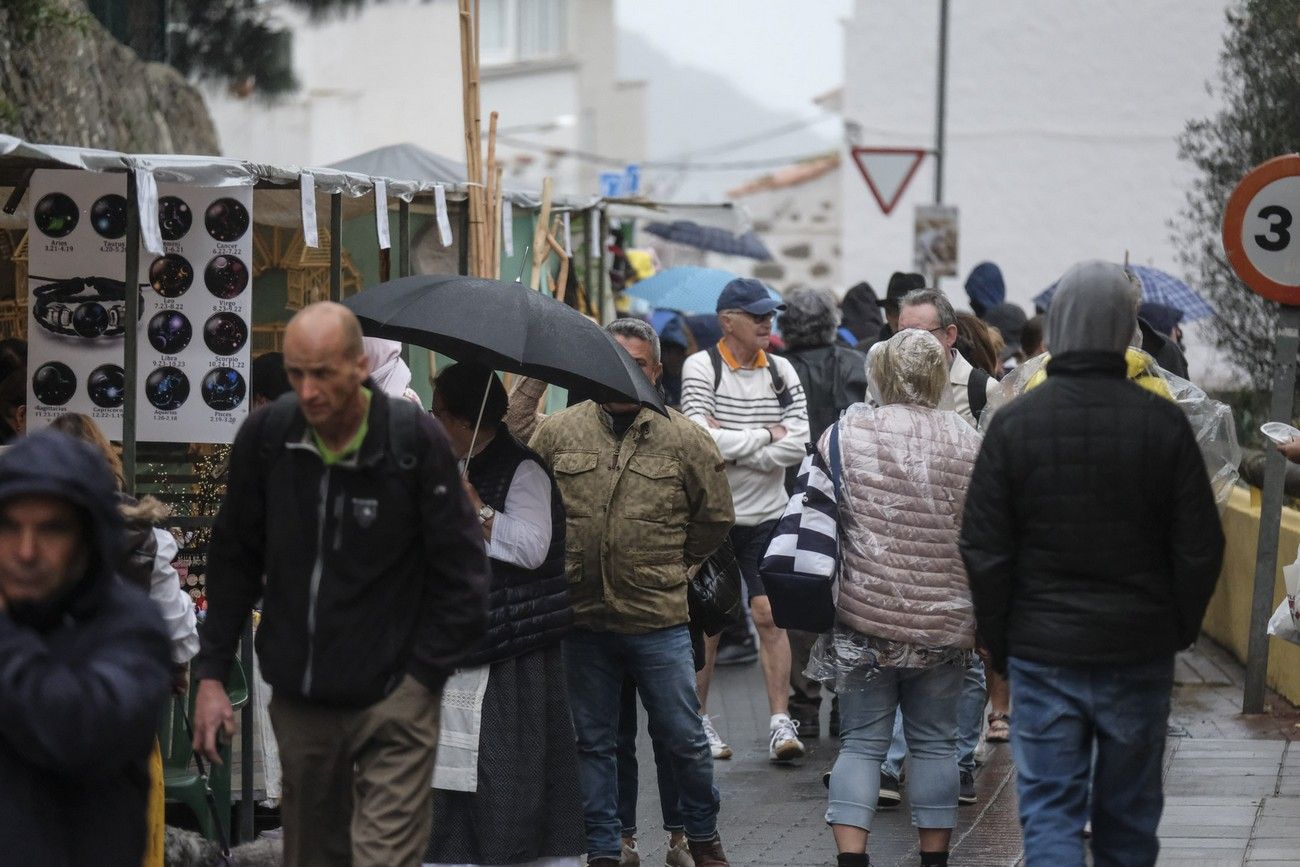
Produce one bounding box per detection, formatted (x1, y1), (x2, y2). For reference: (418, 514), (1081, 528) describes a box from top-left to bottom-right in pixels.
(529, 400), (736, 633)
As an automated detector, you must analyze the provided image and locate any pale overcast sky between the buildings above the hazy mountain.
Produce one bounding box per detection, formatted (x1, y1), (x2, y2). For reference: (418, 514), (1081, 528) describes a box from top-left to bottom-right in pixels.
(615, 0), (853, 117)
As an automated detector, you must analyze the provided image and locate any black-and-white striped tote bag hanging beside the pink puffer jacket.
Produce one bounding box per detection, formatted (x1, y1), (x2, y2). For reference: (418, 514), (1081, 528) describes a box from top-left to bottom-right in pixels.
(759, 422), (840, 632)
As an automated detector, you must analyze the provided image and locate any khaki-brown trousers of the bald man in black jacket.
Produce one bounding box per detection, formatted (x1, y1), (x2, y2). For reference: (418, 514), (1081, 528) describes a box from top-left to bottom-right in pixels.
(270, 675), (439, 867)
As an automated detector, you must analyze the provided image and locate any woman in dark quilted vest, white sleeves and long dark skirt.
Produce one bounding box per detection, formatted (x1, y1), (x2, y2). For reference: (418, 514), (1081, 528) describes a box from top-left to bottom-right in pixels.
(424, 364), (586, 866)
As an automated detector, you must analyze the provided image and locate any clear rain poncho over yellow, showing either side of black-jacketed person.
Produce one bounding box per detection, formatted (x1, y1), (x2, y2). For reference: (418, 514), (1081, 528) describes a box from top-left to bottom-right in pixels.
(980, 347), (1242, 512)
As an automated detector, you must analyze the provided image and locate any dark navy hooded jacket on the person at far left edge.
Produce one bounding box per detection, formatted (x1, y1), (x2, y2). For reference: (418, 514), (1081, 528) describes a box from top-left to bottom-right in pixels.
(0, 432), (170, 867)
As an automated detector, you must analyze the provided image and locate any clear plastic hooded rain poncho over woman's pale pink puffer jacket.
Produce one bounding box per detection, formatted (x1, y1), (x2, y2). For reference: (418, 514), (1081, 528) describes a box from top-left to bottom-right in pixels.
(805, 330), (979, 692)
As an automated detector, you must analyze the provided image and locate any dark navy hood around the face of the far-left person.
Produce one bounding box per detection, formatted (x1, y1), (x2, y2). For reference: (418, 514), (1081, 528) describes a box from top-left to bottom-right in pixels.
(0, 430), (122, 627)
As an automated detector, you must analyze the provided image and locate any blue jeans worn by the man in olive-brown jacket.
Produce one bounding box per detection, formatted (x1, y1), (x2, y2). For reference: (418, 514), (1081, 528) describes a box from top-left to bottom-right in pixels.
(564, 625), (720, 858)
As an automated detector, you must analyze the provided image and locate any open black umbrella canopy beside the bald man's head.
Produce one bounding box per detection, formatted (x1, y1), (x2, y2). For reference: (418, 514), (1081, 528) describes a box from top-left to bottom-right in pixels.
(343, 274), (668, 415)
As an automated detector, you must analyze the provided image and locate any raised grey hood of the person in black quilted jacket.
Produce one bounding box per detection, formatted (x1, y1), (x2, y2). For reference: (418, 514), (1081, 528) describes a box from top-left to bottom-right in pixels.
(1045, 260), (1141, 355)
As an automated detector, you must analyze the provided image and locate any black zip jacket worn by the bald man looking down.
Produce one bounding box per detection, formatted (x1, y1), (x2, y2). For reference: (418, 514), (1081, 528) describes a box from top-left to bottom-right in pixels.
(194, 387), (489, 707)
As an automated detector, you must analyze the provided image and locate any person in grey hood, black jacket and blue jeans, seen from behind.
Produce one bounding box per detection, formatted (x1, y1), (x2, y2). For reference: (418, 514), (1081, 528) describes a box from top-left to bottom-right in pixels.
(961, 261), (1223, 867)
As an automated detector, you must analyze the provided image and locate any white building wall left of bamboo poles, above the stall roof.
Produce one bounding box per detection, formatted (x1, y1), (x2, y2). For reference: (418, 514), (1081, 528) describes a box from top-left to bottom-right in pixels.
(204, 0), (464, 165)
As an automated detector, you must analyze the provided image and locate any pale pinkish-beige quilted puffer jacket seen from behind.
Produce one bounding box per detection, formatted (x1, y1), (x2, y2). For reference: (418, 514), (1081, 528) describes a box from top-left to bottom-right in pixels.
(819, 403), (980, 649)
